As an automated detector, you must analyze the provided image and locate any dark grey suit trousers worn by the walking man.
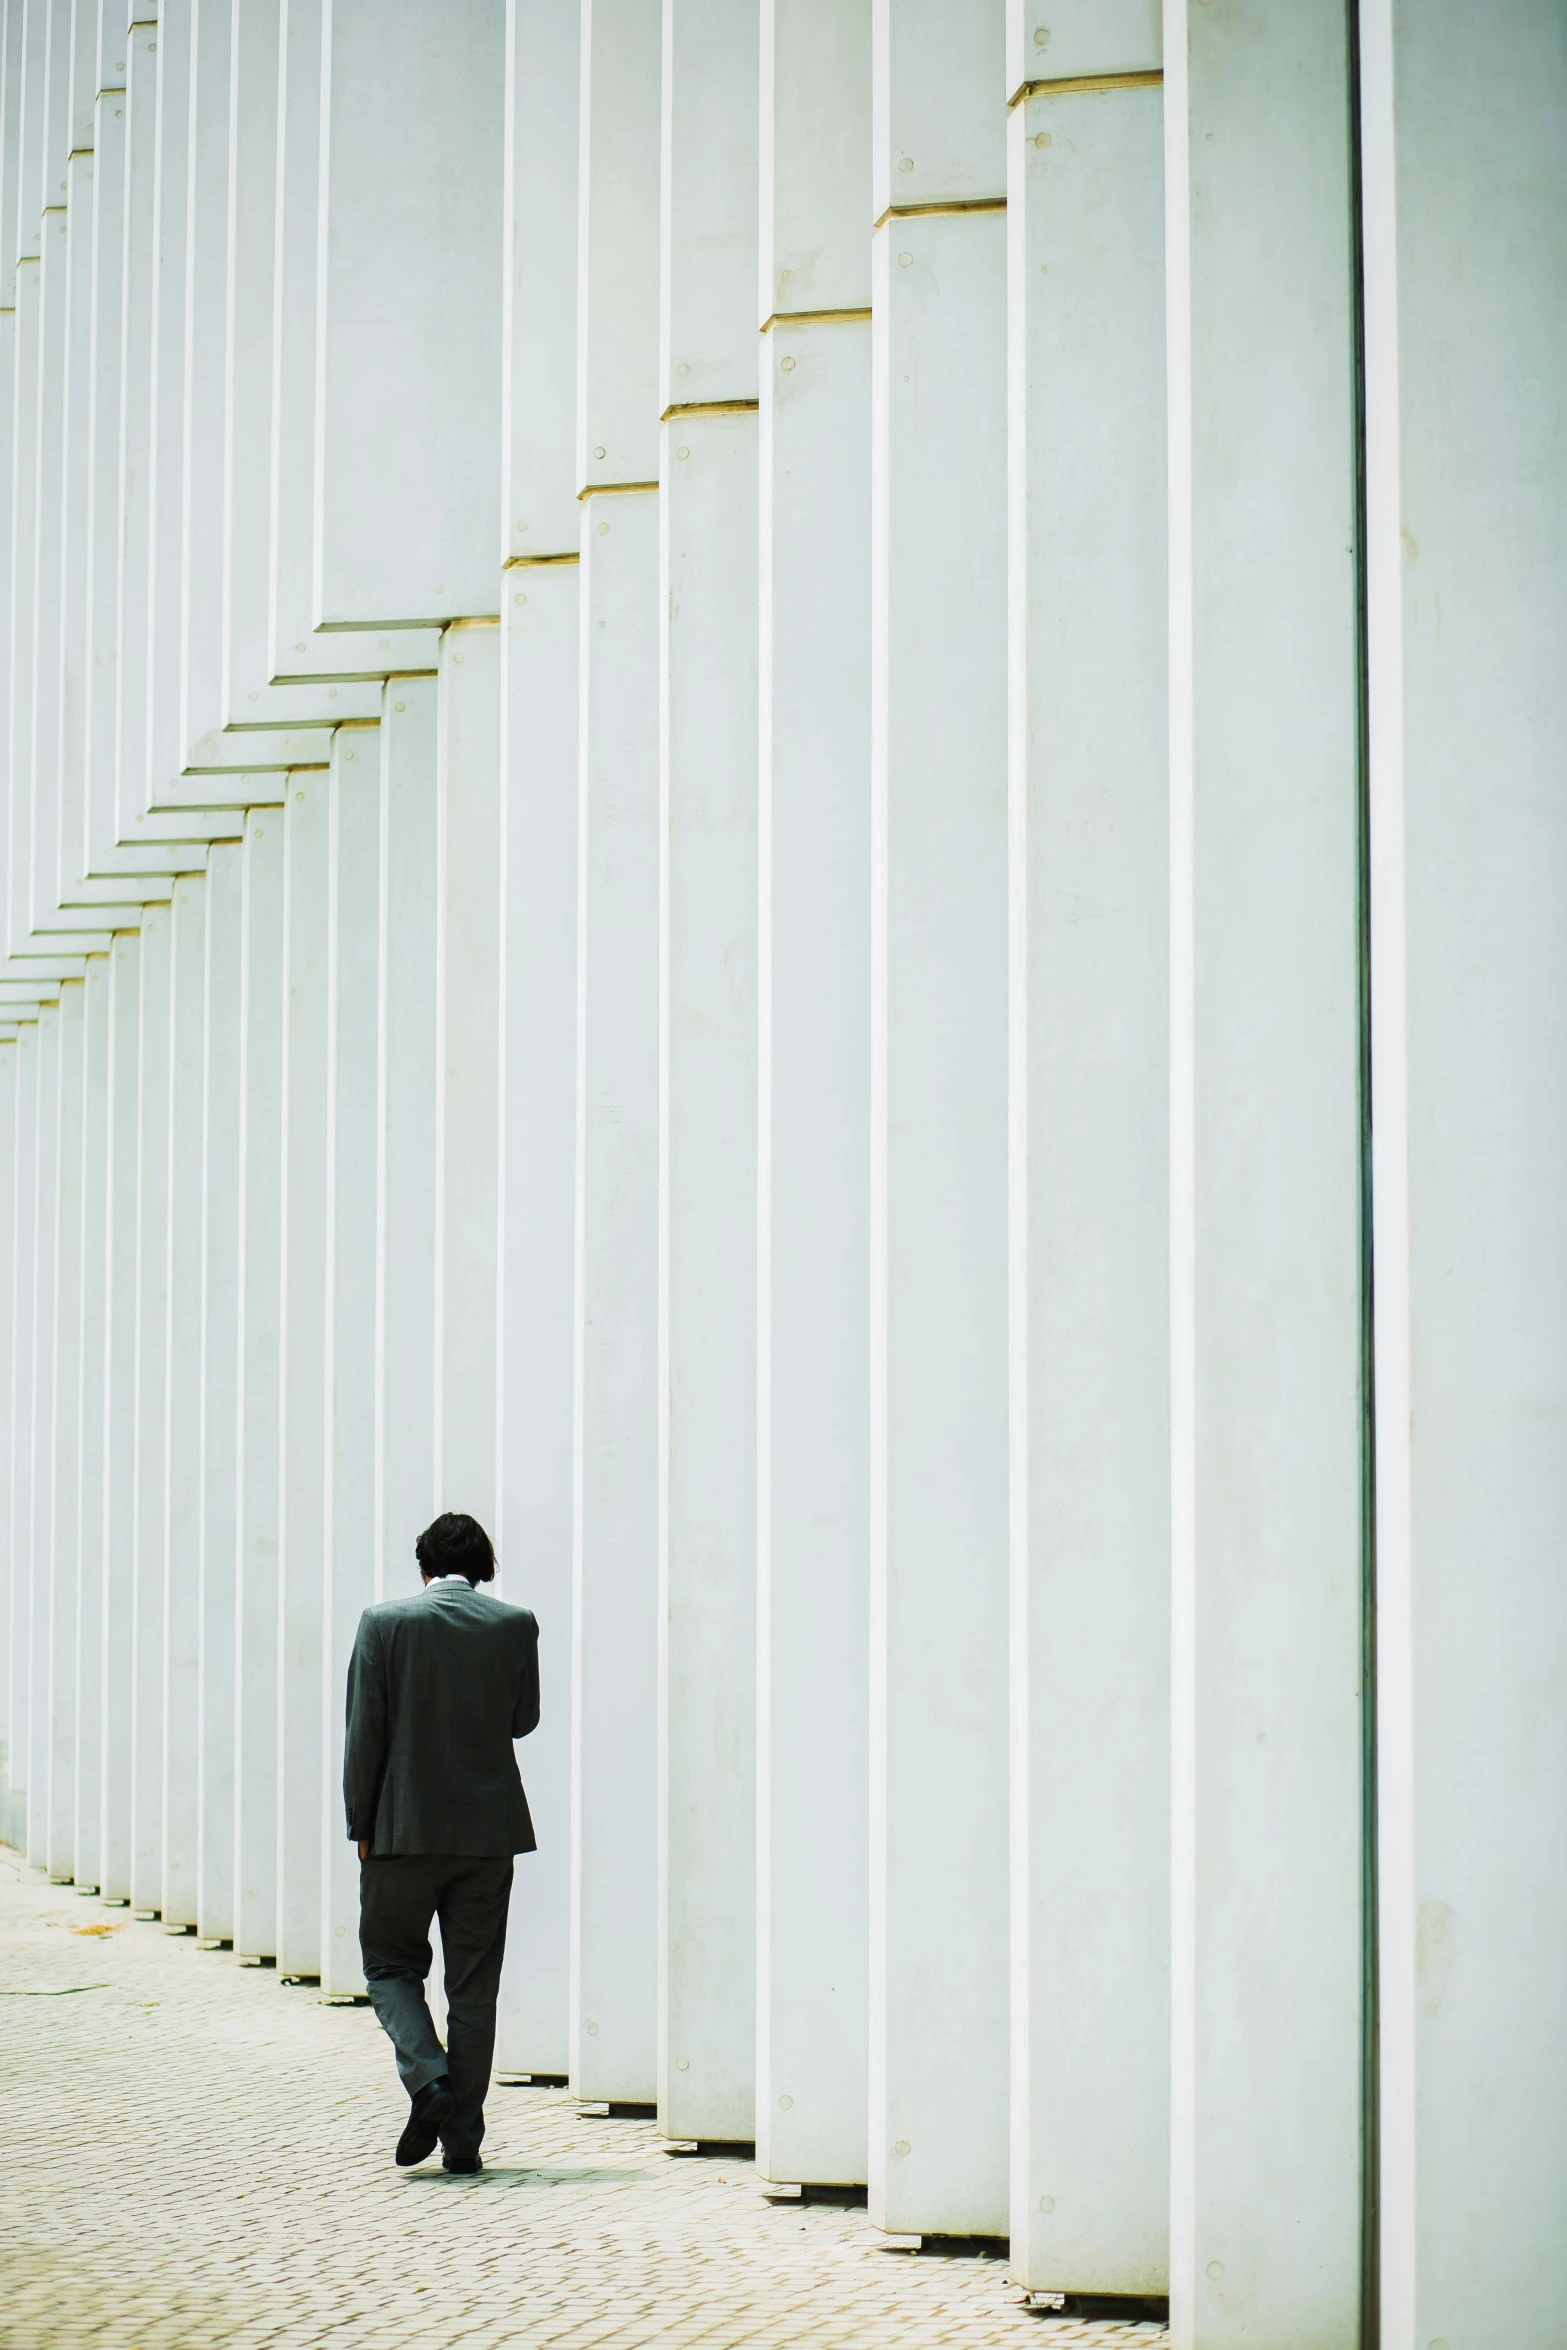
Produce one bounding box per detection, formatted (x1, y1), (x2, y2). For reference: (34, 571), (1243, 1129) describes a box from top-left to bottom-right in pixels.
(359, 1852), (512, 2155)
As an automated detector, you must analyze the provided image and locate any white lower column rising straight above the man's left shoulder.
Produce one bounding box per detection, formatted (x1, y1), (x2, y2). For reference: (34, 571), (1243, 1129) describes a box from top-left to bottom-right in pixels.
(373, 677), (437, 1597)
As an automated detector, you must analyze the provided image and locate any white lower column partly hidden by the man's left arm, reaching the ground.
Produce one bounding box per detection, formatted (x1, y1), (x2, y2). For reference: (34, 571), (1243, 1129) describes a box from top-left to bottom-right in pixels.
(317, 726), (378, 1993)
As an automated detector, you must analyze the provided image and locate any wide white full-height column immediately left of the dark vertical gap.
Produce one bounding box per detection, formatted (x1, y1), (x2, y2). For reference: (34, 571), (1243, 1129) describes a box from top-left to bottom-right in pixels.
(1165, 0), (1365, 2350)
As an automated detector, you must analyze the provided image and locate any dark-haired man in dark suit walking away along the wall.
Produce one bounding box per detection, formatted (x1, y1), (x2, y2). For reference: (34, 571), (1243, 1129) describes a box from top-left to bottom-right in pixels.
(343, 1511), (538, 2171)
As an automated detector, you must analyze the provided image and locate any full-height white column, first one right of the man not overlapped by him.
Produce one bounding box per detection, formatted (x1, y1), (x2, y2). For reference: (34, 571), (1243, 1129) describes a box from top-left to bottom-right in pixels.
(569, 0), (660, 2101)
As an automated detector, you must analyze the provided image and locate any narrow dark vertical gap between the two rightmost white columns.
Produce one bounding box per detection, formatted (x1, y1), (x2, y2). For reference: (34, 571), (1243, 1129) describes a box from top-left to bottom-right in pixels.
(1344, 0), (1381, 2350)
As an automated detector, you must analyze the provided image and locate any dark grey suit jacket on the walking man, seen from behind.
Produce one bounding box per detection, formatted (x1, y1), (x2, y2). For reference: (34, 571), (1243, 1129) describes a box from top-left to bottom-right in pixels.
(343, 1577), (538, 1859)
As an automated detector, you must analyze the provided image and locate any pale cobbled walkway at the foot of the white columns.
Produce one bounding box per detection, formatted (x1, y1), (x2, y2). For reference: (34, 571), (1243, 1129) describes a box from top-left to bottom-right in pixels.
(0, 1854), (1165, 2350)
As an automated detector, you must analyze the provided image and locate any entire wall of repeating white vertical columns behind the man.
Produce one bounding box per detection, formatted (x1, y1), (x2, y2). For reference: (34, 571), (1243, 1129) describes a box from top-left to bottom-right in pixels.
(0, 0), (1567, 2350)
